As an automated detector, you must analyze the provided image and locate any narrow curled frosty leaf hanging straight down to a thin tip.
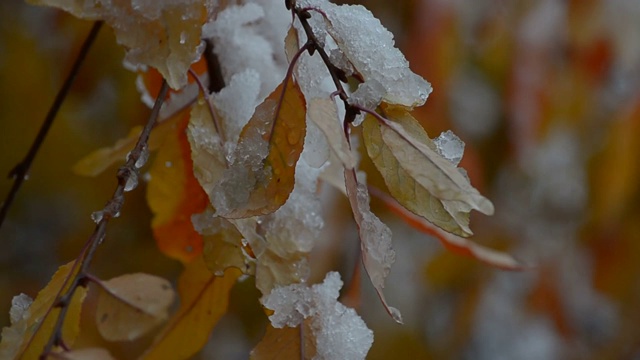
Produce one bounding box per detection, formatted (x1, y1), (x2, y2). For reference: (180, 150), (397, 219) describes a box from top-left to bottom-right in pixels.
(344, 170), (402, 324)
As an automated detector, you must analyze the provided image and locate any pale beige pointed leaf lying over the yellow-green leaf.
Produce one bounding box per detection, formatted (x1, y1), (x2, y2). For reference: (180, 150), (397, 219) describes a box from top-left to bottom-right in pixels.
(367, 107), (494, 225)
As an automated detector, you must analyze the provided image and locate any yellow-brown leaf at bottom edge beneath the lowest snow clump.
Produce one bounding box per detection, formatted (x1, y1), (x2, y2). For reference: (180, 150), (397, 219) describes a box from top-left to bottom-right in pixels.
(249, 319), (316, 360)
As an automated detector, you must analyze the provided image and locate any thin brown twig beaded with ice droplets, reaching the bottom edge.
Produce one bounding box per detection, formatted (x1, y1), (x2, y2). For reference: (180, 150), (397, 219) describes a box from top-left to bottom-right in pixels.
(34, 80), (169, 360)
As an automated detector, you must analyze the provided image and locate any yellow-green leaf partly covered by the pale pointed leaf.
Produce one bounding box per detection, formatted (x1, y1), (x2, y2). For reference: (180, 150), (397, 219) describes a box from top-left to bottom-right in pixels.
(362, 112), (472, 236)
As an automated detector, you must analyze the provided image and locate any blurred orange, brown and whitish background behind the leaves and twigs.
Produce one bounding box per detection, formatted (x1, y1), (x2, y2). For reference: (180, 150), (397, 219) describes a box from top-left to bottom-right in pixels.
(0, 0), (640, 359)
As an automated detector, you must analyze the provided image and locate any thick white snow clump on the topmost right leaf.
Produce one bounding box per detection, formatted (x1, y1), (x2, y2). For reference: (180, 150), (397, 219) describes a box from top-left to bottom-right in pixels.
(298, 0), (431, 109)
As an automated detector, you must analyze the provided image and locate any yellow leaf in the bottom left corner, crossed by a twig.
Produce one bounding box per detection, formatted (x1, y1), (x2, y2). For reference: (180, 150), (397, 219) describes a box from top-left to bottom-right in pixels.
(0, 262), (87, 359)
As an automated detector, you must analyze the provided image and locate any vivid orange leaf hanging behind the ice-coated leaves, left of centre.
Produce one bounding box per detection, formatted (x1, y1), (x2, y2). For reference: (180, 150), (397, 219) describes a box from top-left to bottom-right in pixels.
(147, 112), (209, 262)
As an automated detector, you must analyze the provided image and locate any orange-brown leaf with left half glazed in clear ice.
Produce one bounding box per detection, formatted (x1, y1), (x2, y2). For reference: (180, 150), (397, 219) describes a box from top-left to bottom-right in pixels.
(212, 78), (306, 218)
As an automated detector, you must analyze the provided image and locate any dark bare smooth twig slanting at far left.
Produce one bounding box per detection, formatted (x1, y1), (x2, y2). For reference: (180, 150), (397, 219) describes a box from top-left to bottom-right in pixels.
(0, 21), (102, 231)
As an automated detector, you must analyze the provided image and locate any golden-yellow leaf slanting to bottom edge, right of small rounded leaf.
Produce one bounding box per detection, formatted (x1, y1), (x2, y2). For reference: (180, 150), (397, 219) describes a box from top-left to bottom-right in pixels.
(142, 258), (242, 360)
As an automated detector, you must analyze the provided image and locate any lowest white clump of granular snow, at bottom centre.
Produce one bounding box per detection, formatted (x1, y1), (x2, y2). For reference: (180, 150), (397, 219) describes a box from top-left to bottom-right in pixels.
(252, 272), (373, 360)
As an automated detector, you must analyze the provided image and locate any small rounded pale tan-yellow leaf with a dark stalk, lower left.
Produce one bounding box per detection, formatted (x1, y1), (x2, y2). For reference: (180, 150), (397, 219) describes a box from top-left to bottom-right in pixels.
(96, 273), (175, 341)
